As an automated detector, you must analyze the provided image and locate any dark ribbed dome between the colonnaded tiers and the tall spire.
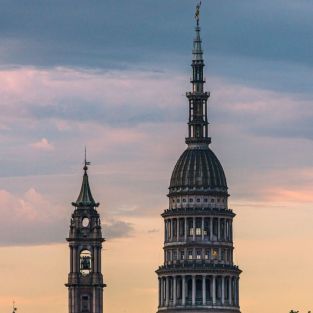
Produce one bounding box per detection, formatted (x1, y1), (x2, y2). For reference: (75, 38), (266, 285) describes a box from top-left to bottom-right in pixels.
(169, 147), (227, 192)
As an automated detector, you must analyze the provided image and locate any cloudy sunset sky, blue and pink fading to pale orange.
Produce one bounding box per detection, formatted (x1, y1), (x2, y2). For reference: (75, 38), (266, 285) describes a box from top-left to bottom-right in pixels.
(0, 0), (313, 313)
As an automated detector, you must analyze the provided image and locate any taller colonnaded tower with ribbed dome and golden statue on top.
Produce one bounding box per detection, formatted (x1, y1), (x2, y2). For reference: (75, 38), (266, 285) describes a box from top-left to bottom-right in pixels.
(156, 5), (241, 313)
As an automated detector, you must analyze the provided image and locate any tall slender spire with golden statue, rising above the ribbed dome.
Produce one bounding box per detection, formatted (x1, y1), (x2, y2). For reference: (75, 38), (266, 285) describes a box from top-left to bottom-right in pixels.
(186, 2), (211, 145)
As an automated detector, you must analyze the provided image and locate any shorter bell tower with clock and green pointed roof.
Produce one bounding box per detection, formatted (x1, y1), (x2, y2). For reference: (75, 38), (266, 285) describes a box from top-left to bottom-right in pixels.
(66, 157), (106, 313)
